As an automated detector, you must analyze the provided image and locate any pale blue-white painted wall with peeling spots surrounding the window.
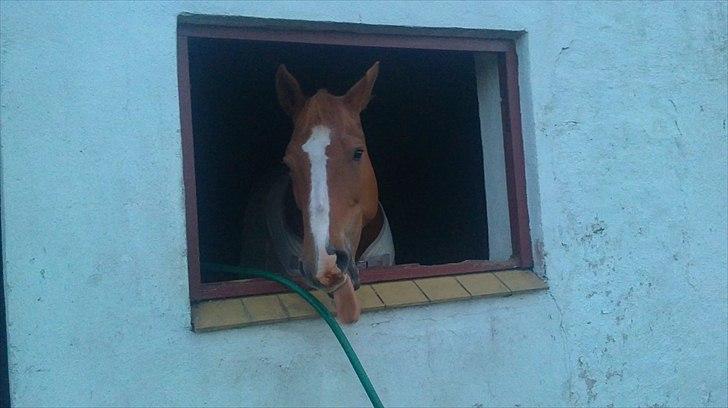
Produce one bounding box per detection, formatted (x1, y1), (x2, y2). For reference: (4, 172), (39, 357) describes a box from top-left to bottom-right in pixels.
(0, 2), (728, 406)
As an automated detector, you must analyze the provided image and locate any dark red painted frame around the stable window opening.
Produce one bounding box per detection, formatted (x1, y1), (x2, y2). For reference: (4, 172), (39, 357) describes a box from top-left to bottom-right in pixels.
(177, 19), (533, 301)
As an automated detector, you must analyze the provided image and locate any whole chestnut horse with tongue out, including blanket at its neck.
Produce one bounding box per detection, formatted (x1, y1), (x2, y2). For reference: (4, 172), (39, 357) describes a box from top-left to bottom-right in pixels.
(243, 62), (395, 323)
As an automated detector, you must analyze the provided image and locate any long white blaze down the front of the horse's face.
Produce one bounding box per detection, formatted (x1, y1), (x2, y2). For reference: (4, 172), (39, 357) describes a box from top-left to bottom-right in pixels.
(302, 126), (331, 270)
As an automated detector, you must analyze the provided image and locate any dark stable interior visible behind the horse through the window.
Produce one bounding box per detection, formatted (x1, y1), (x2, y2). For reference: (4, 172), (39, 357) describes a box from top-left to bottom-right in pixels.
(189, 38), (488, 282)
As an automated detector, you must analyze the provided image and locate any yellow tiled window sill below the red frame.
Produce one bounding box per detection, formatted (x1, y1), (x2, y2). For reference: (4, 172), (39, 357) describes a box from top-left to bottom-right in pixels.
(192, 270), (548, 333)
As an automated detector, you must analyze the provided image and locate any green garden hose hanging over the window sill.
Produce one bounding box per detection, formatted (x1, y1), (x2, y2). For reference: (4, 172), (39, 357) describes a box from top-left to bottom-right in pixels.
(202, 263), (384, 408)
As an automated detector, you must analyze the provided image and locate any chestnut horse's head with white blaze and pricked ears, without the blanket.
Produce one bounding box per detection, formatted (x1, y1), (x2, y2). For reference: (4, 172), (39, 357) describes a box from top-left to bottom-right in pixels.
(276, 63), (379, 320)
